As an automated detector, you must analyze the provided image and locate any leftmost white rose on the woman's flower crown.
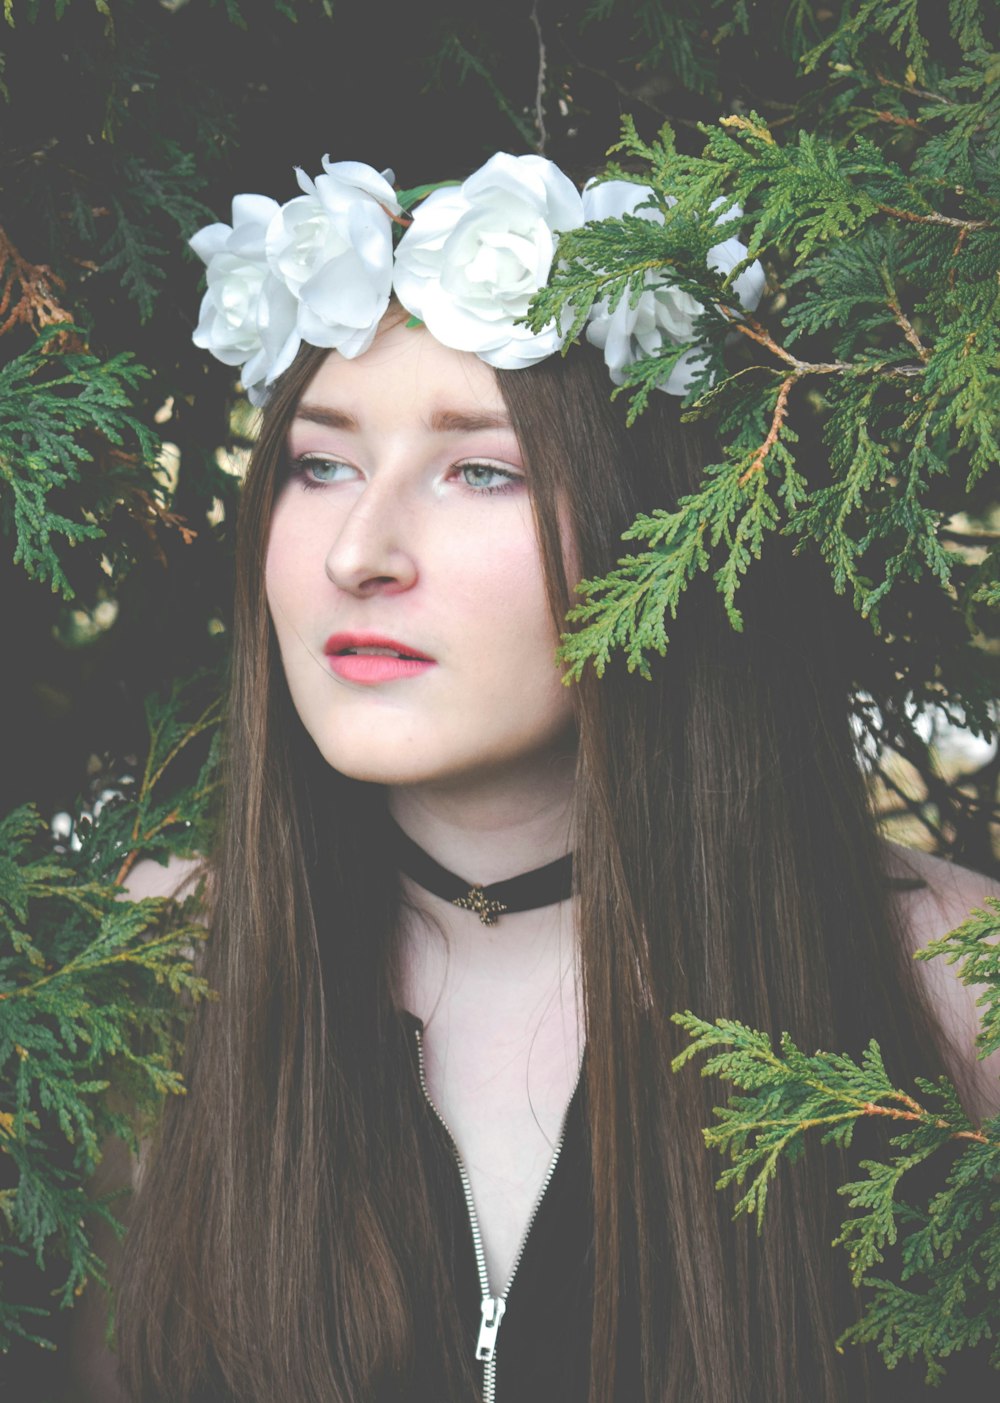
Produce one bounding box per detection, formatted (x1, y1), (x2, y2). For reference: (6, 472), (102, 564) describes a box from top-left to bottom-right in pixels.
(191, 195), (300, 404)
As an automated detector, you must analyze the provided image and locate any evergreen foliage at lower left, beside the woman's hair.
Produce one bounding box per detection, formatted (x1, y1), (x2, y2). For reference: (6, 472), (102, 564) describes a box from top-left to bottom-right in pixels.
(0, 689), (217, 1351)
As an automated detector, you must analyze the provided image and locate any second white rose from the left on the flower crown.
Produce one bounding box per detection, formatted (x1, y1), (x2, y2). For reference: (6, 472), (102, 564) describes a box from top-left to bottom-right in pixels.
(265, 156), (400, 359)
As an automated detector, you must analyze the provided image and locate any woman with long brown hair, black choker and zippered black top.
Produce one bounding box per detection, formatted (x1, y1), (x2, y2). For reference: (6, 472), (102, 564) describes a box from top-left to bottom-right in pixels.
(87, 159), (996, 1403)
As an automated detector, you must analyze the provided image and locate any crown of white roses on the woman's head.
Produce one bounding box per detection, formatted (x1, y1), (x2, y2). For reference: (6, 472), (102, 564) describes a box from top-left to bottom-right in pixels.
(191, 152), (764, 404)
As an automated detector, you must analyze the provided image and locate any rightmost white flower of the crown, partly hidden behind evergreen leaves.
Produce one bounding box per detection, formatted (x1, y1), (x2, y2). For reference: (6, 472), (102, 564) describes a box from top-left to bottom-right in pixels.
(583, 180), (764, 394)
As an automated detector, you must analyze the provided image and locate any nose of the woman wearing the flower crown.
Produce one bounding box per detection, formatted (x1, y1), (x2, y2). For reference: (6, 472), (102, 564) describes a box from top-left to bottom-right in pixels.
(325, 483), (417, 596)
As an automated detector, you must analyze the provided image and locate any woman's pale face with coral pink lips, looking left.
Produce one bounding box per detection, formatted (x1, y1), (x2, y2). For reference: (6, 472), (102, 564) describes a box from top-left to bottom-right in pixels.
(266, 323), (572, 784)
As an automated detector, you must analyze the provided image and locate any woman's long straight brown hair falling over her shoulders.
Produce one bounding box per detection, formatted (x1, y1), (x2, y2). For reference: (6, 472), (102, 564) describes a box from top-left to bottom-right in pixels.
(118, 333), (940, 1403)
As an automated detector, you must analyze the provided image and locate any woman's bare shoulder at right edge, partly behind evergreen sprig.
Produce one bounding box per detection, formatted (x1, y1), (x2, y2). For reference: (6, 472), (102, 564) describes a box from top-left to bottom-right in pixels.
(885, 843), (1000, 1118)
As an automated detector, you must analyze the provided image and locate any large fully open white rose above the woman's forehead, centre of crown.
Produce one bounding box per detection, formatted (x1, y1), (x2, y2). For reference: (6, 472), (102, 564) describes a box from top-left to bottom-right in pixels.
(393, 152), (583, 370)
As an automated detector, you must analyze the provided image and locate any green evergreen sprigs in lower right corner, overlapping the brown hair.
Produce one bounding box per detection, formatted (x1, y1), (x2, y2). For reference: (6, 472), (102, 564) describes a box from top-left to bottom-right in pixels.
(673, 899), (1000, 1383)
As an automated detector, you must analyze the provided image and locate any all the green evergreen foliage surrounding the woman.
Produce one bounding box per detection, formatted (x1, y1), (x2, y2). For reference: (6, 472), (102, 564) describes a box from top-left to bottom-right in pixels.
(0, 0), (1000, 1395)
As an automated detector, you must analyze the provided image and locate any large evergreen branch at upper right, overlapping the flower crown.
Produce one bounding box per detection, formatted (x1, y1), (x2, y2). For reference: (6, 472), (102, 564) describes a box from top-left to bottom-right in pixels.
(529, 94), (1000, 690)
